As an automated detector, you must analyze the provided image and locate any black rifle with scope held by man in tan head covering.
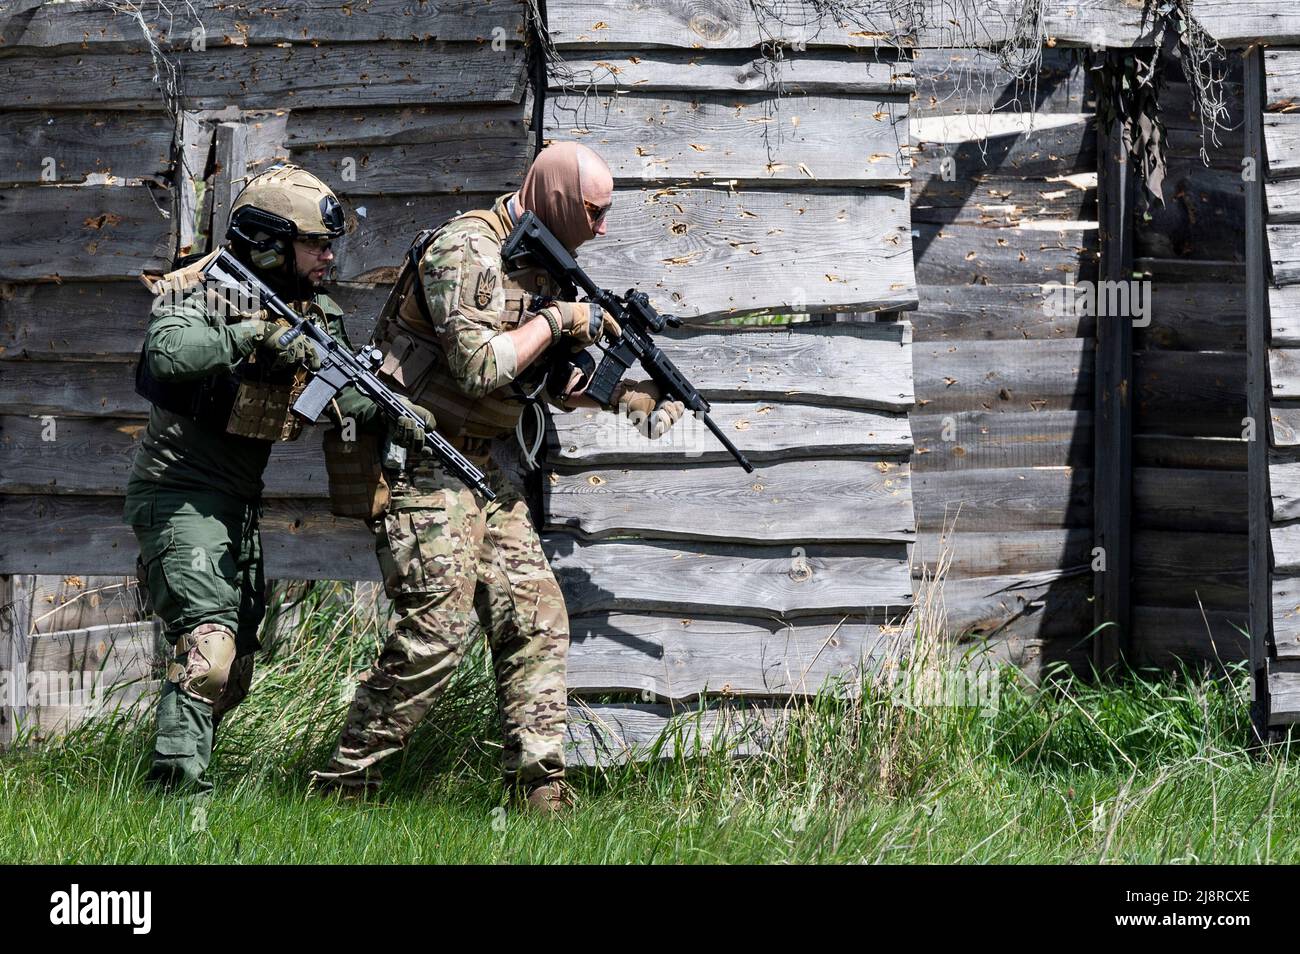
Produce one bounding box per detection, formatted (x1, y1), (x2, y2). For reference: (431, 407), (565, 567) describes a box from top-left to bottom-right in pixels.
(502, 212), (754, 473)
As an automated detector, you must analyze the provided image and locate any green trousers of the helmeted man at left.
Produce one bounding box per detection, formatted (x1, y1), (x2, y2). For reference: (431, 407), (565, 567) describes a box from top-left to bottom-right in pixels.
(125, 482), (267, 790)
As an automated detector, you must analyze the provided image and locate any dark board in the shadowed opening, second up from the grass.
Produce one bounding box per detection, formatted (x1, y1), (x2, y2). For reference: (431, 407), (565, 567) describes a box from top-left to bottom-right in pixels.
(1132, 526), (1249, 611)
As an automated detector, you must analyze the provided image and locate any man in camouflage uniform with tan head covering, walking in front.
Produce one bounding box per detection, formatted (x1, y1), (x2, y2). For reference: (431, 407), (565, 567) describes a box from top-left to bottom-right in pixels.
(313, 143), (684, 811)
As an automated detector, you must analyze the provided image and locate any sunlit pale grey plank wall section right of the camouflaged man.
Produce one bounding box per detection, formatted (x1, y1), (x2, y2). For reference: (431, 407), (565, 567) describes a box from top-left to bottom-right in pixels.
(542, 0), (915, 760)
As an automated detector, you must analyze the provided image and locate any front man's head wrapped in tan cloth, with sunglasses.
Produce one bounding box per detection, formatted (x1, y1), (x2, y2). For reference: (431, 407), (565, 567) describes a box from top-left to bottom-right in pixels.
(519, 142), (614, 251)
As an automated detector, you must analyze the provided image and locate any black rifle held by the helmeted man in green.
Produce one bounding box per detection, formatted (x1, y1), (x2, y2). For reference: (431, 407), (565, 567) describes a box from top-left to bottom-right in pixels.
(203, 250), (497, 500)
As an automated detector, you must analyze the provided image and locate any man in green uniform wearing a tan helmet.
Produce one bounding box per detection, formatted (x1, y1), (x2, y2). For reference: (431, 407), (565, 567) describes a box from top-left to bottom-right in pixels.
(125, 165), (433, 790)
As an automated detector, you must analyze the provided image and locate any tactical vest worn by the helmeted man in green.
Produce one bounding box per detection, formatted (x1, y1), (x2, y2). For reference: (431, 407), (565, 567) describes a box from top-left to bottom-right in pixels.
(135, 252), (310, 441)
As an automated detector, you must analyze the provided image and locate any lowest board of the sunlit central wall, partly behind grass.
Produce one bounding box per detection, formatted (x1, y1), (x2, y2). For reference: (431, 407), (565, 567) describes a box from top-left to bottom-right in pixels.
(564, 701), (781, 766)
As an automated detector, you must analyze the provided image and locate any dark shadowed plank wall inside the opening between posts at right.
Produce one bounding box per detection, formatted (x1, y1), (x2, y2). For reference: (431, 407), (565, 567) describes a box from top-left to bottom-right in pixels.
(1131, 48), (1248, 665)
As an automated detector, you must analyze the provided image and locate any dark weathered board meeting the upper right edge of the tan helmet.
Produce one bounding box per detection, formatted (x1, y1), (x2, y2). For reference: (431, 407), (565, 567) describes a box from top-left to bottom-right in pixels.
(294, 139), (532, 197)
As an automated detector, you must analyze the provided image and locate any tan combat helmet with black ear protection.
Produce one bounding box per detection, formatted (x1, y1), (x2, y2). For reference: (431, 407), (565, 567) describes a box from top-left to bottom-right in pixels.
(226, 162), (343, 269)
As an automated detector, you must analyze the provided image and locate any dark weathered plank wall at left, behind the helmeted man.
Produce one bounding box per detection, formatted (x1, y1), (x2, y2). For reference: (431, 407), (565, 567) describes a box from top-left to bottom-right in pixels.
(0, 0), (530, 743)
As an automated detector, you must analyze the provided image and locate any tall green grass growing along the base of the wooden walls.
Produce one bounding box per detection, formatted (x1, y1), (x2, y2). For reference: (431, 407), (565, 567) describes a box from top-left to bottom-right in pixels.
(0, 574), (1300, 863)
